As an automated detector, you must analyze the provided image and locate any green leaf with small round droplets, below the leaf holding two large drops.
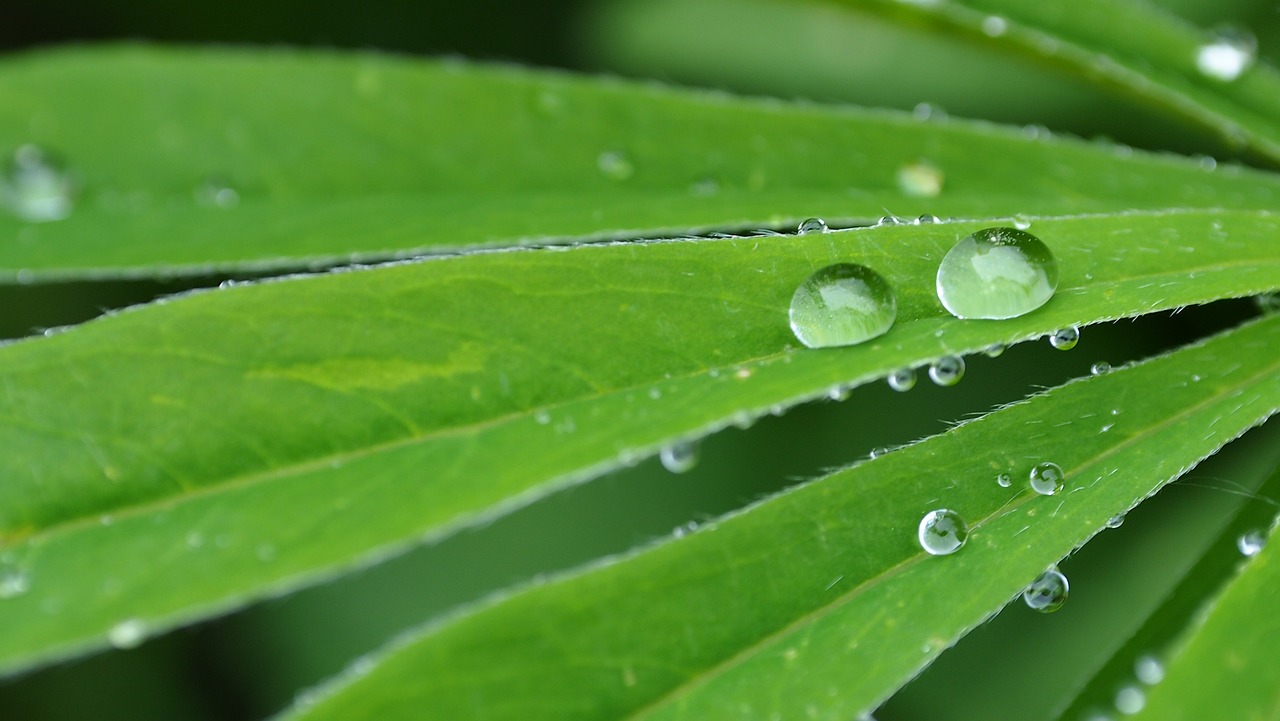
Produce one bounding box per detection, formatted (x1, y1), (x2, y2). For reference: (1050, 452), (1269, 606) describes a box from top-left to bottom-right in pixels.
(287, 316), (1280, 721)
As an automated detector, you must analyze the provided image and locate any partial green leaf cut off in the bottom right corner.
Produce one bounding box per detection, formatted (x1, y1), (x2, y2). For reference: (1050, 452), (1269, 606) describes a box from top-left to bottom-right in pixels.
(1135, 484), (1280, 720)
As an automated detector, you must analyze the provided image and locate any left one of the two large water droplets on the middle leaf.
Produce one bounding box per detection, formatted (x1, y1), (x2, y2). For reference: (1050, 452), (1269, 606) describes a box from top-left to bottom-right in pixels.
(790, 263), (897, 348)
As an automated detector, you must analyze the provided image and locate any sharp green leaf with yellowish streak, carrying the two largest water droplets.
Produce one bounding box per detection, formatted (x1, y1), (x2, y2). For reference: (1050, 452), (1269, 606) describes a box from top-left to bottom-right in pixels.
(0, 211), (1280, 670)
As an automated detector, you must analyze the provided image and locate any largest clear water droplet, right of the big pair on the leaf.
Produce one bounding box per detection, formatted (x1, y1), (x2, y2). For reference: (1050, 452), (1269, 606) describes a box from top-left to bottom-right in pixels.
(937, 228), (1057, 319)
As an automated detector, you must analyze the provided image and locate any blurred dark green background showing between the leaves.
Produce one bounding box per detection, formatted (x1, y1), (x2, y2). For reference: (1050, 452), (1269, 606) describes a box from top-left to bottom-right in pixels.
(0, 0), (1280, 721)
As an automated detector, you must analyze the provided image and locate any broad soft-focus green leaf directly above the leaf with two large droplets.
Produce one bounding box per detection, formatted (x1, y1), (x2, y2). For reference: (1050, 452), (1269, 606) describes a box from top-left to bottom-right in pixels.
(0, 46), (1280, 282)
